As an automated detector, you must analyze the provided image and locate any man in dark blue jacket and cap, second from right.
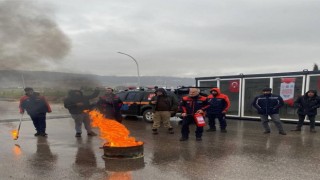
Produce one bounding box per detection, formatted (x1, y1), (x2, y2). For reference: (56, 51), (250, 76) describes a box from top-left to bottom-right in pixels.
(252, 87), (286, 135)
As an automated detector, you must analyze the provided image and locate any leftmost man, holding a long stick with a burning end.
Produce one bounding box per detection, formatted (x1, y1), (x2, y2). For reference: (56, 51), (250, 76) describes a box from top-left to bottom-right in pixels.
(19, 87), (51, 136)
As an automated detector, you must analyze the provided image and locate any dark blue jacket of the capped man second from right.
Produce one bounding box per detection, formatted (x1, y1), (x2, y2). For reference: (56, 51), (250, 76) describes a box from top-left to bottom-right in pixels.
(252, 94), (284, 115)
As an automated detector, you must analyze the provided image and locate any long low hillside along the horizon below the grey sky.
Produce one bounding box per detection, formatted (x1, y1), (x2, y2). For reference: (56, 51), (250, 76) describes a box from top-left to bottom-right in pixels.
(0, 70), (195, 88)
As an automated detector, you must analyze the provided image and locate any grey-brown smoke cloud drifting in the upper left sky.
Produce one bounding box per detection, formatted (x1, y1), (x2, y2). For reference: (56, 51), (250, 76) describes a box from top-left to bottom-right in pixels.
(0, 0), (70, 70)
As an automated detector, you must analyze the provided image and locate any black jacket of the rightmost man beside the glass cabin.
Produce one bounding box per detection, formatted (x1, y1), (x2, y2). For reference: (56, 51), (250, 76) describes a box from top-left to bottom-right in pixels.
(294, 91), (320, 116)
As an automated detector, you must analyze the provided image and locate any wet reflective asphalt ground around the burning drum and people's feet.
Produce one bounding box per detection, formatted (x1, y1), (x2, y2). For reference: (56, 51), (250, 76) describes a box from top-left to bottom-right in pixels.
(0, 118), (320, 180)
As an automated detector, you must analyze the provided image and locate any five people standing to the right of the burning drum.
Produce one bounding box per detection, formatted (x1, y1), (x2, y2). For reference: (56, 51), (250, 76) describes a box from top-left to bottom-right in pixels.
(152, 88), (320, 141)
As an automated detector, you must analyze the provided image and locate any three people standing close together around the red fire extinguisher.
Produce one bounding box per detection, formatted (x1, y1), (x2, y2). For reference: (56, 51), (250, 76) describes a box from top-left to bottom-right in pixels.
(151, 88), (230, 141)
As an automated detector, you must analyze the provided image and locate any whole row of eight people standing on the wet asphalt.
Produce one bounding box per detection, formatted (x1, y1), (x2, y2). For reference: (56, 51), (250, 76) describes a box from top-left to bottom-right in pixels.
(19, 87), (320, 141)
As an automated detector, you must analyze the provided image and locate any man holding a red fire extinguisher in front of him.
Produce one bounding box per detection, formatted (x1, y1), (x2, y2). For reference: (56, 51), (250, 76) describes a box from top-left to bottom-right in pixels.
(180, 88), (209, 141)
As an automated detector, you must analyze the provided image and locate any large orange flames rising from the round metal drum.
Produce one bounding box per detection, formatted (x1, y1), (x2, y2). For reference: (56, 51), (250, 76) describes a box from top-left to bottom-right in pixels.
(88, 110), (143, 147)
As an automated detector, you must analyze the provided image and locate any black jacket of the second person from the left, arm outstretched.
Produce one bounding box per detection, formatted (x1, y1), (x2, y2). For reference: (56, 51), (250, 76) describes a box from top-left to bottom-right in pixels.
(64, 90), (99, 114)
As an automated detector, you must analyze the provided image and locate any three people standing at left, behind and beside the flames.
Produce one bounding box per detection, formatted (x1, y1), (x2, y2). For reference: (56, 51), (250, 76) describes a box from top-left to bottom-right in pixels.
(19, 87), (122, 137)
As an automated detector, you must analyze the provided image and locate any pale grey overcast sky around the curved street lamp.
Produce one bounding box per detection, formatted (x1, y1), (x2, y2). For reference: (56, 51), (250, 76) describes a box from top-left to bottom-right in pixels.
(2, 0), (320, 77)
